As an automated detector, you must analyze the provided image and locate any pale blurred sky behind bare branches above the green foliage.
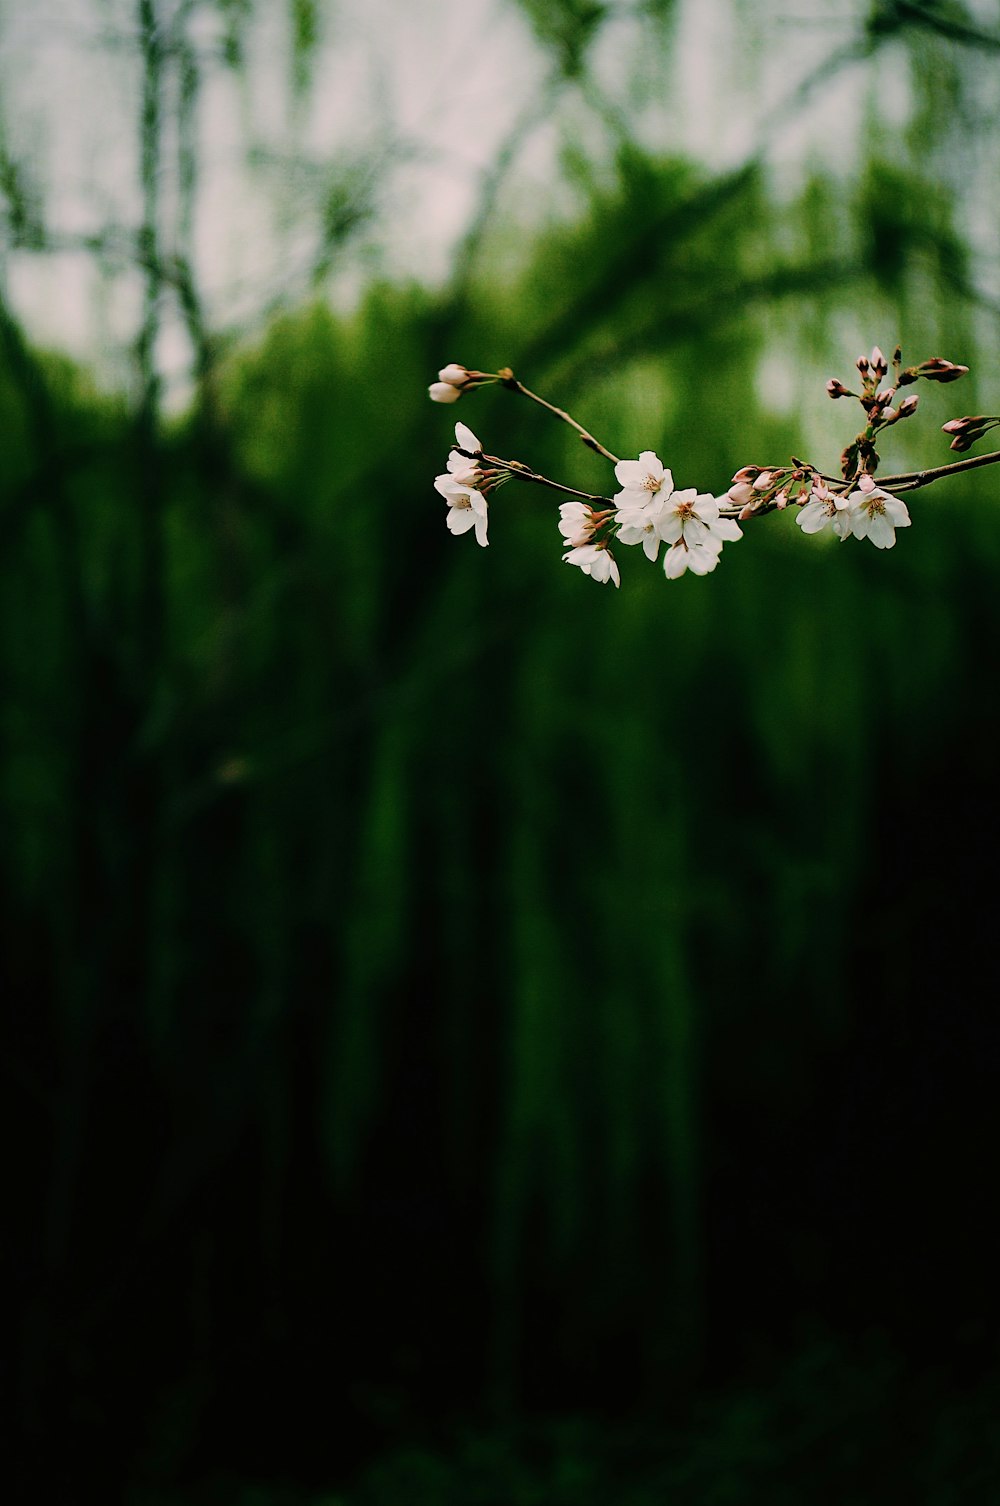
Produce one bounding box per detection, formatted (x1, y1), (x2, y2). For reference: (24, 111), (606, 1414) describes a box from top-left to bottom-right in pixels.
(0, 0), (1000, 404)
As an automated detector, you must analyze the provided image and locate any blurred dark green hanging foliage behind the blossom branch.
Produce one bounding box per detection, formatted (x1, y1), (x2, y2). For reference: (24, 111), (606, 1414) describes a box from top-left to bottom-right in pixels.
(0, 5), (1000, 1506)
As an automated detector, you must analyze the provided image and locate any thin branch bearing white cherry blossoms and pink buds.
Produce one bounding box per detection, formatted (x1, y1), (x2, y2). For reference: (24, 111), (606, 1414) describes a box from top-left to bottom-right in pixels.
(429, 346), (1000, 586)
